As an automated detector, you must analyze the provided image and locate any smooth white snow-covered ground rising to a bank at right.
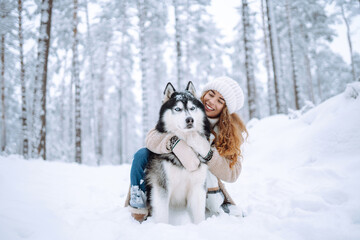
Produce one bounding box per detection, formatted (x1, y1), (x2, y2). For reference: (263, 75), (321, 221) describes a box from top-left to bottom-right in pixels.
(0, 83), (360, 240)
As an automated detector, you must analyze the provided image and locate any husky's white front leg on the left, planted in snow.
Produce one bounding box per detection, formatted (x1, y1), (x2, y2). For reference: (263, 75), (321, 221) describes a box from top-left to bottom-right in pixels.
(152, 188), (169, 223)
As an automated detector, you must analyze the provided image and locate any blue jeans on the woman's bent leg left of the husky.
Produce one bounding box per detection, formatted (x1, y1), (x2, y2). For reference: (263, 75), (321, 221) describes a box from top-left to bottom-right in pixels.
(130, 148), (150, 192)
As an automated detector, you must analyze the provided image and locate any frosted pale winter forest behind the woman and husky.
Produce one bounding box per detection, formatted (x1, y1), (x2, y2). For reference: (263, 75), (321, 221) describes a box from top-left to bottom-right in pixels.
(0, 0), (360, 165)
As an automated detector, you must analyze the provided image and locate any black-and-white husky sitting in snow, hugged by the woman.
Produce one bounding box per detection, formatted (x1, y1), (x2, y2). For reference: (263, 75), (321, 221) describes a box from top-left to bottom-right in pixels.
(145, 82), (210, 223)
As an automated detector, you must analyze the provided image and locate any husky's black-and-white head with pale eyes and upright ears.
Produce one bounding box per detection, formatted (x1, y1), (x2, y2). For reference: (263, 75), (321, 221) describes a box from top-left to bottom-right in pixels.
(156, 81), (210, 136)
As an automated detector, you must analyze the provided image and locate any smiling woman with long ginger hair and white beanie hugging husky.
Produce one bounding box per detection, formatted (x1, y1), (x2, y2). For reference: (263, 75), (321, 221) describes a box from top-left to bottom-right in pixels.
(125, 77), (248, 221)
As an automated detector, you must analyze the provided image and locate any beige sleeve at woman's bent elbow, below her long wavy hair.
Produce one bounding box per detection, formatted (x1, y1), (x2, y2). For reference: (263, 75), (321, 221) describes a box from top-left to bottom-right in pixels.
(207, 148), (241, 182)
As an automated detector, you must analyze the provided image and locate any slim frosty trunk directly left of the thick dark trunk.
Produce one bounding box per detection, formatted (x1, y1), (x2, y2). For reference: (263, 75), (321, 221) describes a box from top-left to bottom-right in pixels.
(18, 0), (29, 159)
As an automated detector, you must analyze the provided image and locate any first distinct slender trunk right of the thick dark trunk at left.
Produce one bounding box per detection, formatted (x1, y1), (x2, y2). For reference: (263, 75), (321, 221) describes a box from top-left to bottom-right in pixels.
(72, 0), (82, 163)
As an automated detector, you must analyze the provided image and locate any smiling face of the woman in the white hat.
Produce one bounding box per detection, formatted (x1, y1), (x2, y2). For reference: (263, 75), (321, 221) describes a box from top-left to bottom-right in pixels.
(203, 90), (225, 118)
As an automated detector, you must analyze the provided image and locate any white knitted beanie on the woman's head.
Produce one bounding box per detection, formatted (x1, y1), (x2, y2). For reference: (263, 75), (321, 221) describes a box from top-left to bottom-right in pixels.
(202, 77), (244, 114)
